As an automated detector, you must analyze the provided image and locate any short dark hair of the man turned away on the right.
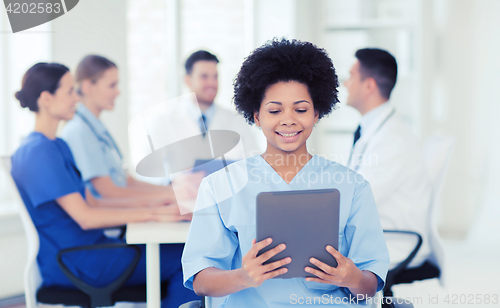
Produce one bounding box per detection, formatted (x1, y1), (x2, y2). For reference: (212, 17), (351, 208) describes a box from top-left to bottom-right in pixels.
(356, 48), (398, 99)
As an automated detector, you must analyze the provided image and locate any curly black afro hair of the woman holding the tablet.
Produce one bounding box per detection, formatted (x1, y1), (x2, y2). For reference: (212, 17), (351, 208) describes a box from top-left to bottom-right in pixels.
(233, 38), (339, 124)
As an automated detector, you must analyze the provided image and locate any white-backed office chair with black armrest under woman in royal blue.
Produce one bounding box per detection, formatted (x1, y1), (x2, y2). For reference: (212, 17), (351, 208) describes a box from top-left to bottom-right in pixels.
(0, 156), (167, 308)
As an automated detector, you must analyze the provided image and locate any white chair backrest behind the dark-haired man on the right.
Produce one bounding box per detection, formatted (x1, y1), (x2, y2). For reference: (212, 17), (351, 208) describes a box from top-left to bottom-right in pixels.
(423, 136), (455, 286)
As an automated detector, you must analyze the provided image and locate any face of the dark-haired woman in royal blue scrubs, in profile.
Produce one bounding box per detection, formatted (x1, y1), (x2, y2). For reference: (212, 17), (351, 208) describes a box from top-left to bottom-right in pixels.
(39, 72), (79, 120)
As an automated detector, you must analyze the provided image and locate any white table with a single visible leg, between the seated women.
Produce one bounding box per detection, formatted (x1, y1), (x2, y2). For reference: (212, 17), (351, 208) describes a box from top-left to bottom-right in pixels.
(127, 222), (190, 308)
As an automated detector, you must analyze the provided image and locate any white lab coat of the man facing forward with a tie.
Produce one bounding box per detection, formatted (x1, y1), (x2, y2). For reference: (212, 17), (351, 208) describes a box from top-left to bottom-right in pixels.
(129, 94), (261, 184)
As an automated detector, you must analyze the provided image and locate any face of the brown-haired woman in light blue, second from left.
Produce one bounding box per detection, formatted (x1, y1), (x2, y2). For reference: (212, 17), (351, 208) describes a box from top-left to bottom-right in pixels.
(83, 67), (120, 111)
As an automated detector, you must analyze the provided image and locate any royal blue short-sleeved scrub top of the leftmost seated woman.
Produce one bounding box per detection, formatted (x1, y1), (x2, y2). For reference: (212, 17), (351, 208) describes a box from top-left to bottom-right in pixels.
(11, 132), (133, 288)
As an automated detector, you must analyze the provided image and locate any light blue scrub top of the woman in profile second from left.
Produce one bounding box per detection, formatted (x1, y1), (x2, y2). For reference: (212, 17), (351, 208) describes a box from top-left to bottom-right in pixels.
(61, 104), (127, 197)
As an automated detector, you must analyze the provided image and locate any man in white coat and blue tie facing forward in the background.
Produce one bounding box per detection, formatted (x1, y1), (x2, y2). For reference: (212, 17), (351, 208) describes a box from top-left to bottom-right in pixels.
(129, 50), (261, 185)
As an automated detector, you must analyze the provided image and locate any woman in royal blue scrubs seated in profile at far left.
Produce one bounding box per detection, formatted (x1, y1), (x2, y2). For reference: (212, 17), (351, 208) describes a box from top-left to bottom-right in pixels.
(12, 63), (196, 307)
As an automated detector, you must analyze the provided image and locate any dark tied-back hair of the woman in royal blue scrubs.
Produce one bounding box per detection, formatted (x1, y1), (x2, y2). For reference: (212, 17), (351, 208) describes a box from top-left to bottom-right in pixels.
(15, 62), (69, 112)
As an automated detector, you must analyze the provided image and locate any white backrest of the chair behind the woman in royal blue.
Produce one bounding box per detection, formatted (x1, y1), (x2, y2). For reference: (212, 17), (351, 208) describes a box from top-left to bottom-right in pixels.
(0, 156), (42, 308)
